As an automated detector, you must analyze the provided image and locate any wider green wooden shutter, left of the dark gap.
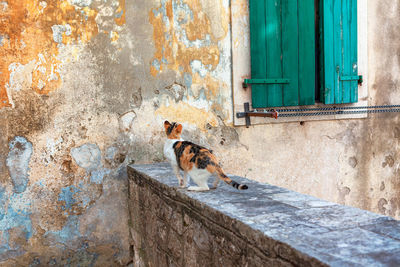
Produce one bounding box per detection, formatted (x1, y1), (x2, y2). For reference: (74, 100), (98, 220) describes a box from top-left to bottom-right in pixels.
(245, 0), (315, 108)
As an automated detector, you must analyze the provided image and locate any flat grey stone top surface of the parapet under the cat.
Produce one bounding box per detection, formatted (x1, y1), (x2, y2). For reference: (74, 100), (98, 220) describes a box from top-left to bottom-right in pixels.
(128, 163), (400, 266)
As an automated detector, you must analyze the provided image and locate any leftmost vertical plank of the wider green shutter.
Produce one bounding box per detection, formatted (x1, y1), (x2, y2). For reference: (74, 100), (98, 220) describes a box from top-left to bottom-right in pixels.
(249, 0), (268, 108)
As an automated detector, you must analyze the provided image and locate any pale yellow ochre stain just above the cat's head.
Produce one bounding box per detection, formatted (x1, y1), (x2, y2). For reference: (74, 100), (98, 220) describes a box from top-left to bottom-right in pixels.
(155, 102), (218, 131)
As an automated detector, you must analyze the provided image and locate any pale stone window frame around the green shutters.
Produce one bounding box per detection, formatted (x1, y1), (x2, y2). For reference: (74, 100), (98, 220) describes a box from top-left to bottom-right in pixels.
(231, 0), (368, 126)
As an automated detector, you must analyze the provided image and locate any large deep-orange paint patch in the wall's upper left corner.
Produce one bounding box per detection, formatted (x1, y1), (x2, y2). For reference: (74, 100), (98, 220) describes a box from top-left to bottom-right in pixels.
(0, 0), (125, 108)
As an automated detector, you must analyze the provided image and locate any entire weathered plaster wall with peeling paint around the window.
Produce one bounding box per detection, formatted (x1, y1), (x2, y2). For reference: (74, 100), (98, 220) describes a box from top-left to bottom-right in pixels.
(0, 0), (400, 266)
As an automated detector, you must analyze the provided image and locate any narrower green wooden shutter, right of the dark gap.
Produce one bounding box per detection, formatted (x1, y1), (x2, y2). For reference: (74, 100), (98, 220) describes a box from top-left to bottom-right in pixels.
(320, 0), (359, 104)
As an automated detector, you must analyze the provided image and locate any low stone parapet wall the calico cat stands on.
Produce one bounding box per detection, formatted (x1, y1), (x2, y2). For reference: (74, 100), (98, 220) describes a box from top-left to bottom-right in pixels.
(128, 163), (400, 266)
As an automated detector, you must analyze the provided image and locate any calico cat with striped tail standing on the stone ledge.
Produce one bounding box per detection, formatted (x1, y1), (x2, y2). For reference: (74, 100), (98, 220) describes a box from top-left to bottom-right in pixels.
(164, 121), (247, 191)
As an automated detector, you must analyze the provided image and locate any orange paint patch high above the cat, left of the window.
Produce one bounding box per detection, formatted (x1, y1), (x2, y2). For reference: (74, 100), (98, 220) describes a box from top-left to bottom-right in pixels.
(149, 0), (220, 76)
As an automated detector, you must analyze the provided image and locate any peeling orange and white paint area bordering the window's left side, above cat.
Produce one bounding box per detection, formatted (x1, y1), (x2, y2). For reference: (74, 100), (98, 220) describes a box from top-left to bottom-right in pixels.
(149, 0), (229, 109)
